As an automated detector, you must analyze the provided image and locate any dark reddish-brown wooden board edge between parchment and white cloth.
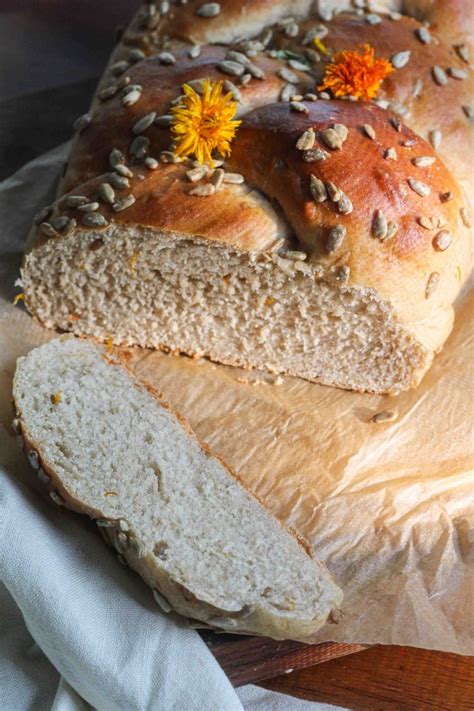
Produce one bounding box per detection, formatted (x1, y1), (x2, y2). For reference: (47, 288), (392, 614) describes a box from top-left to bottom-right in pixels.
(201, 631), (367, 686)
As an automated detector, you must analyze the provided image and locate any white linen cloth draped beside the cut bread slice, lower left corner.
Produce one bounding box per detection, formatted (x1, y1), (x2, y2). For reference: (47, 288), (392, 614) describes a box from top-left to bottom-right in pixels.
(0, 146), (348, 711)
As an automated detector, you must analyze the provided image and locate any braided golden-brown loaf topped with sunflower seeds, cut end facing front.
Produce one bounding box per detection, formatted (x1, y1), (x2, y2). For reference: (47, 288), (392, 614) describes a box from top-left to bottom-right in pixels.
(17, 0), (473, 393)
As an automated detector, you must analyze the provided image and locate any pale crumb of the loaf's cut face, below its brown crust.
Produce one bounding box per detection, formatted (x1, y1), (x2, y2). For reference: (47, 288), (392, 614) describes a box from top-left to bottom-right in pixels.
(22, 226), (429, 392)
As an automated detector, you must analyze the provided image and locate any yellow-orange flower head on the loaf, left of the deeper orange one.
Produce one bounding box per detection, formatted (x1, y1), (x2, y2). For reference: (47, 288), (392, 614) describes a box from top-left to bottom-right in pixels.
(171, 79), (241, 166)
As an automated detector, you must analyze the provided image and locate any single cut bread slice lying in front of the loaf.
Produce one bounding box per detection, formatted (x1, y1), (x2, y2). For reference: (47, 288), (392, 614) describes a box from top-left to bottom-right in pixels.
(13, 336), (342, 639)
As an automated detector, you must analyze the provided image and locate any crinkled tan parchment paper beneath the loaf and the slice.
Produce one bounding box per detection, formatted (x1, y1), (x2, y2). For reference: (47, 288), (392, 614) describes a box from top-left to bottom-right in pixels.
(0, 147), (474, 654)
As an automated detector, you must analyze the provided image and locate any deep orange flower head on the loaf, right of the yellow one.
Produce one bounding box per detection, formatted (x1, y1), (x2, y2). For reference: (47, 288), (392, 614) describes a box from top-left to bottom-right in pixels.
(318, 44), (394, 101)
